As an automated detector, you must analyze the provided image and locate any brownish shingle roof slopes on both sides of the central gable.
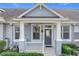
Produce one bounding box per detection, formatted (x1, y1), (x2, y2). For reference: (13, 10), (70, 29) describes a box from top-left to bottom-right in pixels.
(0, 8), (79, 21)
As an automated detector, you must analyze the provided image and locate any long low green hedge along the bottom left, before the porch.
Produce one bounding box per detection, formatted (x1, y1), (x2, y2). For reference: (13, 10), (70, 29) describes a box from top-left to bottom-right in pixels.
(0, 51), (43, 56)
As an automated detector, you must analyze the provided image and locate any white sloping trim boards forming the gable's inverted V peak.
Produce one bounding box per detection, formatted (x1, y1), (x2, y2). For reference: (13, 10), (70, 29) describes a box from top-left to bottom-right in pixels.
(18, 4), (64, 18)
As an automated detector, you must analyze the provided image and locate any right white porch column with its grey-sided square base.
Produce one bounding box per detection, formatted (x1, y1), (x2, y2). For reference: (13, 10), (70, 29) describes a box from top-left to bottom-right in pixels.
(56, 23), (62, 55)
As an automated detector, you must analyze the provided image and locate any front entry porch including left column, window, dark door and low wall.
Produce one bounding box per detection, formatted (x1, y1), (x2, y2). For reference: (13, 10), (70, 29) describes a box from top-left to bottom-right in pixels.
(19, 23), (61, 56)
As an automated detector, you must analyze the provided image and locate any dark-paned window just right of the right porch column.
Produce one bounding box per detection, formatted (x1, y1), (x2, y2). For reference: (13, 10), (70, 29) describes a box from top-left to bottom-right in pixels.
(61, 25), (70, 39)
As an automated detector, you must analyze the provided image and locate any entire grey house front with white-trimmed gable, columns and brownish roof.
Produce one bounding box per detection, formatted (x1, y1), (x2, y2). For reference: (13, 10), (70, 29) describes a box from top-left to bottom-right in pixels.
(0, 4), (79, 55)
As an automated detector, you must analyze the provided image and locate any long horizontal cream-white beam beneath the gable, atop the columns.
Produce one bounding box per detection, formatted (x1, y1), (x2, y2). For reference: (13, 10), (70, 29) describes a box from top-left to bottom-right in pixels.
(13, 18), (68, 23)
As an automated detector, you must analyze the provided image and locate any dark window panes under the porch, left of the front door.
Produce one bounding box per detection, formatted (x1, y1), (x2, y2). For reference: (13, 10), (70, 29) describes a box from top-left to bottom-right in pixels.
(33, 25), (40, 40)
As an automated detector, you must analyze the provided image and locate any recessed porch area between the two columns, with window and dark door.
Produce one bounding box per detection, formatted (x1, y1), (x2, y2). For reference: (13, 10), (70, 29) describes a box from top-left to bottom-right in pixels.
(24, 24), (55, 54)
